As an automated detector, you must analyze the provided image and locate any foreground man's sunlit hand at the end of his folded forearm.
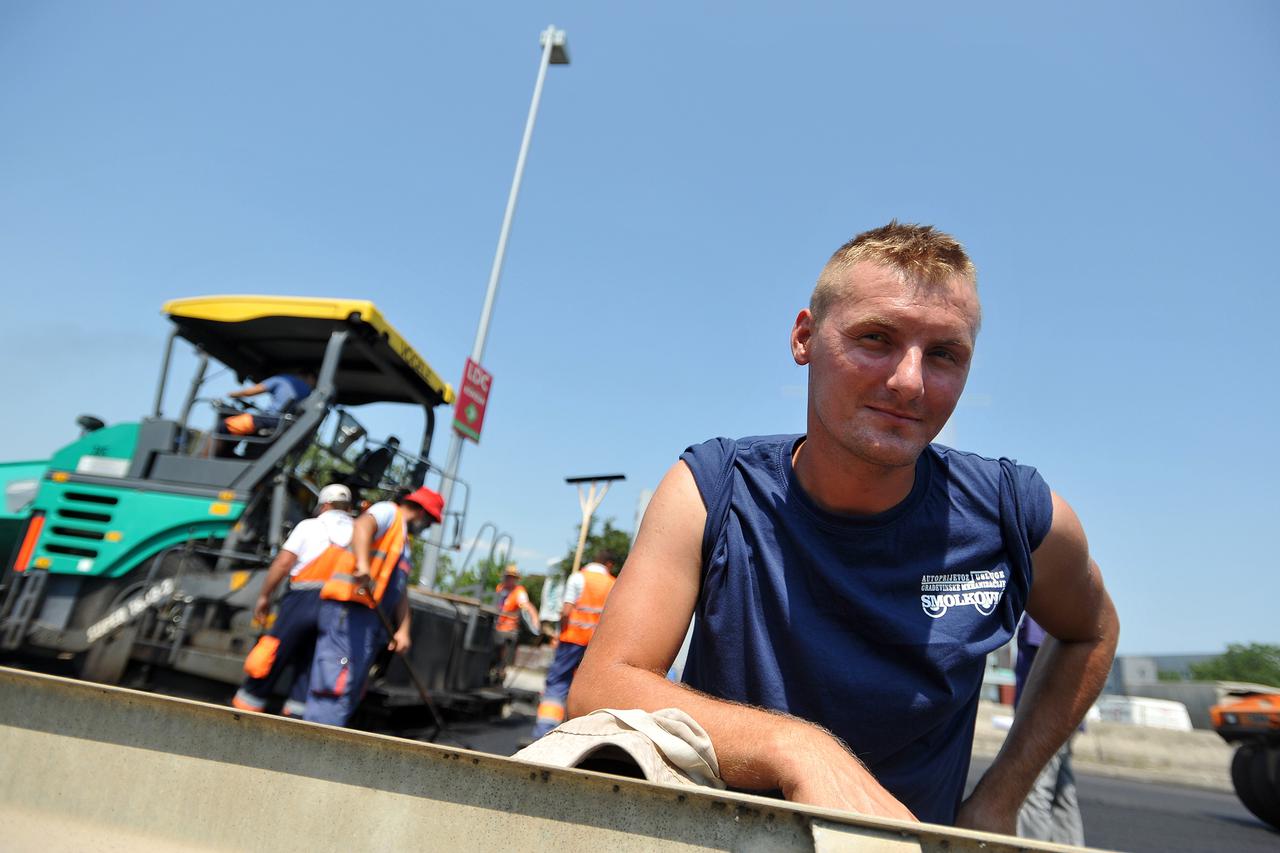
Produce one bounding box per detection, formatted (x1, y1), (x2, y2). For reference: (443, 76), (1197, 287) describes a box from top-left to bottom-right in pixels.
(780, 724), (916, 821)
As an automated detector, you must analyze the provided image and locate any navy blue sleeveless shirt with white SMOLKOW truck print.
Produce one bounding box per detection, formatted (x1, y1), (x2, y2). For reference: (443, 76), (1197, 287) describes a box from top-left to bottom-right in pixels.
(681, 435), (1053, 824)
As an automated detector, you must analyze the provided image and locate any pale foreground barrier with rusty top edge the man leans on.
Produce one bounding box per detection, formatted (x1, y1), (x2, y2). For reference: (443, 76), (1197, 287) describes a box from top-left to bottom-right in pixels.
(0, 667), (1100, 853)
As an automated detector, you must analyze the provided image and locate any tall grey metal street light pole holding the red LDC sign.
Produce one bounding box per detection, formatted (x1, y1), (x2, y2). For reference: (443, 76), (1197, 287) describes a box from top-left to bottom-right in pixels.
(420, 24), (568, 587)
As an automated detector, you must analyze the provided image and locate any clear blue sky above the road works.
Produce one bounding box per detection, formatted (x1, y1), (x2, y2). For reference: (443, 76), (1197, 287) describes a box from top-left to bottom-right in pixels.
(0, 0), (1280, 653)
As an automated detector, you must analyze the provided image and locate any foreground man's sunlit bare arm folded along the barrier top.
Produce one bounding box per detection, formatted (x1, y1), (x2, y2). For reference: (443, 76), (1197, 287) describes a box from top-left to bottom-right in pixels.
(568, 462), (914, 820)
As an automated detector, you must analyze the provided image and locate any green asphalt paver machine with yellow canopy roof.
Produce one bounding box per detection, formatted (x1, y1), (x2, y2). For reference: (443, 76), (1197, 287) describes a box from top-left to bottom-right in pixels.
(0, 296), (503, 707)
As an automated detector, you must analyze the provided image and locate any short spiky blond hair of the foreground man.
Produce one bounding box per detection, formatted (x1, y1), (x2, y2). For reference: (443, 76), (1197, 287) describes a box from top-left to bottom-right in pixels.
(809, 219), (978, 320)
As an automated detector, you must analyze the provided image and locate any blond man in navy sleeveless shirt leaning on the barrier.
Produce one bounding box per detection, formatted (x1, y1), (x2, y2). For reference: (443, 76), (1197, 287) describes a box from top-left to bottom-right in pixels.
(568, 222), (1119, 834)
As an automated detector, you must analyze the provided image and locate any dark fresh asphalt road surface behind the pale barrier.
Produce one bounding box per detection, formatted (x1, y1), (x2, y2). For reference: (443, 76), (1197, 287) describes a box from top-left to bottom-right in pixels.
(439, 715), (1280, 853)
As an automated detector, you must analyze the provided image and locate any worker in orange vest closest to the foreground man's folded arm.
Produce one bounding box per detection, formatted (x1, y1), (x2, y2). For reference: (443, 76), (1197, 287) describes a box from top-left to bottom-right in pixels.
(534, 549), (616, 739)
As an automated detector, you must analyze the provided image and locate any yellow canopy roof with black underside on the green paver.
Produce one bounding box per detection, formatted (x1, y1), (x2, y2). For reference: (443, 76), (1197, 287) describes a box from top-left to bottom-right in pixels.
(164, 296), (454, 405)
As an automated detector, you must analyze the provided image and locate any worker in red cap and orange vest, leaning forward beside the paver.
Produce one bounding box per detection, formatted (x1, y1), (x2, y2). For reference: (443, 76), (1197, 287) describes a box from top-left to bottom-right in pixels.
(303, 488), (444, 726)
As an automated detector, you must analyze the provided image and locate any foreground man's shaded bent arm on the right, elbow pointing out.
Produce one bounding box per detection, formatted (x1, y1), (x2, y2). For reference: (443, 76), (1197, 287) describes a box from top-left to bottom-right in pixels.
(957, 494), (1120, 834)
